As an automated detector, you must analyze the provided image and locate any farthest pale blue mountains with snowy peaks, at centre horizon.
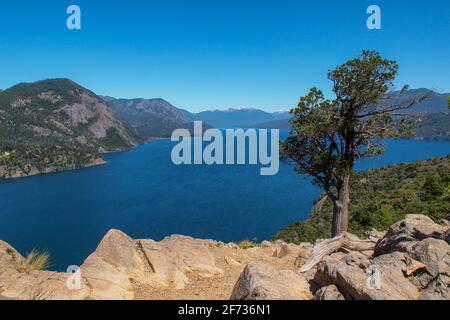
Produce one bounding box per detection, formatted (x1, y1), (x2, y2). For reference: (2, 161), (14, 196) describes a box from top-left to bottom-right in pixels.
(193, 108), (290, 128)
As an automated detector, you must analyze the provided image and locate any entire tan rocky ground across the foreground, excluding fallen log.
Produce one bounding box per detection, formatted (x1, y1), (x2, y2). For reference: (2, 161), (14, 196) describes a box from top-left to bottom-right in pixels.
(0, 215), (450, 300)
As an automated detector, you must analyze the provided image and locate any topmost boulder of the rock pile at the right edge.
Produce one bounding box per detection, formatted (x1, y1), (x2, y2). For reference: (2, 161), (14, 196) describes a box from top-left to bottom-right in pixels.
(375, 214), (448, 255)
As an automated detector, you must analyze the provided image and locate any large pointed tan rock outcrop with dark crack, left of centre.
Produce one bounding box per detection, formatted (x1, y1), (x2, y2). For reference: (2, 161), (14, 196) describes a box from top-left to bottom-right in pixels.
(81, 230), (223, 299)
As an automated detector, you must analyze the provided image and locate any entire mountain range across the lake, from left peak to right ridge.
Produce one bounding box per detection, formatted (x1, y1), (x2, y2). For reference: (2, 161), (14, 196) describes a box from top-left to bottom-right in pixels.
(0, 79), (450, 179)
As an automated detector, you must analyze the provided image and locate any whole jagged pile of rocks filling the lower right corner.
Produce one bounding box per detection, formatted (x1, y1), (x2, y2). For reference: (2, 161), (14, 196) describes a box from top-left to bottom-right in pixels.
(313, 215), (450, 300)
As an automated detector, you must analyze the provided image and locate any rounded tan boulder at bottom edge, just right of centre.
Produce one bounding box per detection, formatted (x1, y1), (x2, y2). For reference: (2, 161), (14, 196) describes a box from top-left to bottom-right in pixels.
(230, 262), (313, 300)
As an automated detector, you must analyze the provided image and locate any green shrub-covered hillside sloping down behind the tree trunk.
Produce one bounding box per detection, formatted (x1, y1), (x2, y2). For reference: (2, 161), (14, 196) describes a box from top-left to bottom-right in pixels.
(274, 155), (450, 243)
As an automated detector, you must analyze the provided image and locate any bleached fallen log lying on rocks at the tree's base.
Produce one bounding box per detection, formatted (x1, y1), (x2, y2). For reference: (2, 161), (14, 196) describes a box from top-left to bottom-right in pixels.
(299, 232), (378, 273)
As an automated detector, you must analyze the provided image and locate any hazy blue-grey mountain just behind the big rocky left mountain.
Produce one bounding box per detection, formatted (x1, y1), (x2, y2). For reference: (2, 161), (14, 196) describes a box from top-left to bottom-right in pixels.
(102, 97), (200, 139)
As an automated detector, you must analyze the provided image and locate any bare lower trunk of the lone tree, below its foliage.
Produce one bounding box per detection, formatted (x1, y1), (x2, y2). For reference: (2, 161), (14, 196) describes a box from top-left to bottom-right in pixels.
(332, 175), (350, 237)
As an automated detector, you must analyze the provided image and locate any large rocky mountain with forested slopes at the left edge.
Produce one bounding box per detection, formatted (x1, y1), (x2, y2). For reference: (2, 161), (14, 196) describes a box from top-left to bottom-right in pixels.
(0, 79), (140, 179)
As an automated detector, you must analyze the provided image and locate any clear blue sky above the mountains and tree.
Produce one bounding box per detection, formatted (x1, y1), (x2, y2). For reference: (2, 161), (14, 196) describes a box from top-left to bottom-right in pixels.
(0, 0), (450, 111)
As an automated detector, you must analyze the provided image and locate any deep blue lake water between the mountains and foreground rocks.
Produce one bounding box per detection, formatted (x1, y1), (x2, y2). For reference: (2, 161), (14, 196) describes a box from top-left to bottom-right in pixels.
(0, 140), (450, 271)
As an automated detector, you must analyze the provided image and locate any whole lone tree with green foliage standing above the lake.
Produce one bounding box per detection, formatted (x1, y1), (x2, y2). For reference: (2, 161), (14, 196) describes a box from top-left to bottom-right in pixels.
(281, 51), (426, 235)
